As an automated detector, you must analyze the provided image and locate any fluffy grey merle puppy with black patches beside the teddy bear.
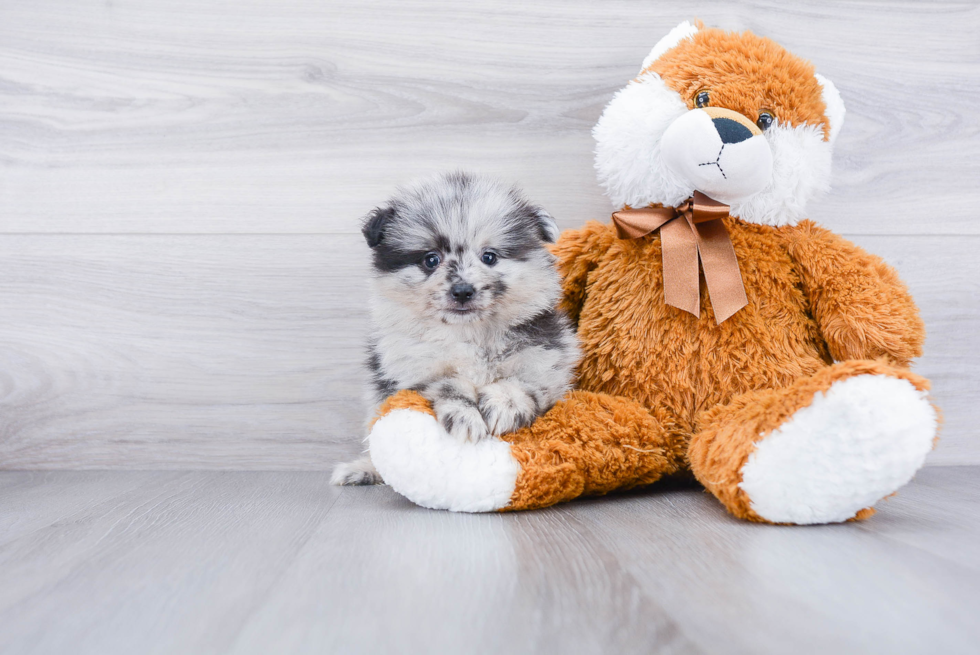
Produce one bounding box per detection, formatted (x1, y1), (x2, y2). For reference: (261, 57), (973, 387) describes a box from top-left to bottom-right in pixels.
(333, 173), (578, 485)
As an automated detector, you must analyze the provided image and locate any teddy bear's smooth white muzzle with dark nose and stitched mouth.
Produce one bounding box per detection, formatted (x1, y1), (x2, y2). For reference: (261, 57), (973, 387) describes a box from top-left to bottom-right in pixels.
(661, 107), (772, 204)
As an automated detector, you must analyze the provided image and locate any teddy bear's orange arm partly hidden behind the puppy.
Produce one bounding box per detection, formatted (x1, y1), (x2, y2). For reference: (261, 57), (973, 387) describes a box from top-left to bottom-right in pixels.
(551, 221), (615, 325)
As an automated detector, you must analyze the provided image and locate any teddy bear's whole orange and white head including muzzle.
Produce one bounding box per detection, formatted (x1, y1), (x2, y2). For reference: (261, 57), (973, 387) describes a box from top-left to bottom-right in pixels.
(593, 22), (844, 225)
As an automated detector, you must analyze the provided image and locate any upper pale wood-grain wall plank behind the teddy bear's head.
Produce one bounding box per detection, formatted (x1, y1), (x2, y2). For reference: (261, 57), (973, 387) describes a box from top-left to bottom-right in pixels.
(0, 0), (980, 234)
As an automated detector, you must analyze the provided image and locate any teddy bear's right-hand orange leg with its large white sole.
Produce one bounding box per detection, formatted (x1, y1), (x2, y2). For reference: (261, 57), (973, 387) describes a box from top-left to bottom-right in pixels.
(688, 361), (938, 524)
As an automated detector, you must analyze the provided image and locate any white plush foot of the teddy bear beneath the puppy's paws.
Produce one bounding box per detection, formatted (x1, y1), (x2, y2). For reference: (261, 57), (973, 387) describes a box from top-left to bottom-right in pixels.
(368, 409), (521, 512)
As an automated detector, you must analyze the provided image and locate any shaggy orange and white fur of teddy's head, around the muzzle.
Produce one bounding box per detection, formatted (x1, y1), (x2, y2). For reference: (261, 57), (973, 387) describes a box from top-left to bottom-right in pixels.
(593, 23), (844, 226)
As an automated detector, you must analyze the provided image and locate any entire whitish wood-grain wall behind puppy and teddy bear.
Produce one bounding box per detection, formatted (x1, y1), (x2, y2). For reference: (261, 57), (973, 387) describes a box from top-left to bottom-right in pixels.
(0, 0), (980, 469)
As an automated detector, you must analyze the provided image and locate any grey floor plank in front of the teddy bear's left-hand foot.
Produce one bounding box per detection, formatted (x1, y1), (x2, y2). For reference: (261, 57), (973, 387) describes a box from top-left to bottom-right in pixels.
(232, 487), (700, 653)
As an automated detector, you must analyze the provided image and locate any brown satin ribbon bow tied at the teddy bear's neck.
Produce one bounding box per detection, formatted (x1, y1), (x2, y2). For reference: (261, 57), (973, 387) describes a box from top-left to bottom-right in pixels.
(613, 191), (749, 323)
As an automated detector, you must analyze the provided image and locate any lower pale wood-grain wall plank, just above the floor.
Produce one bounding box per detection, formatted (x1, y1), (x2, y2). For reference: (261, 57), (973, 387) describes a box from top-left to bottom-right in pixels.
(0, 235), (980, 470)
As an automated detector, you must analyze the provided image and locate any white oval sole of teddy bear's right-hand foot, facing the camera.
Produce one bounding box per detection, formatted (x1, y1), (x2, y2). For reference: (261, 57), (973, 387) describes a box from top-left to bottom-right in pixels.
(739, 375), (938, 524)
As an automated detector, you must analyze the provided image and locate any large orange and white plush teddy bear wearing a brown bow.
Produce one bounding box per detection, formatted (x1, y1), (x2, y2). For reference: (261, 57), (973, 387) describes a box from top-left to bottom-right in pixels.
(368, 22), (939, 524)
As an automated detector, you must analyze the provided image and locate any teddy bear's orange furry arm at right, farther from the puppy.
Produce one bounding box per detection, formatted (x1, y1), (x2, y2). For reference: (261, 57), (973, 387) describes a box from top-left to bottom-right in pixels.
(790, 221), (925, 367)
